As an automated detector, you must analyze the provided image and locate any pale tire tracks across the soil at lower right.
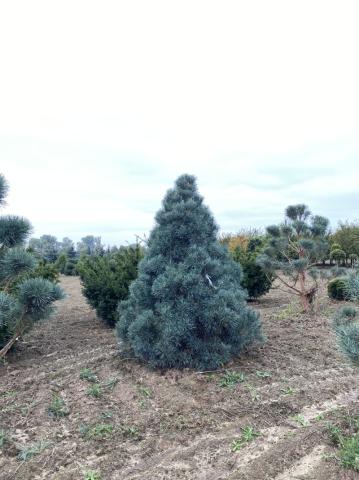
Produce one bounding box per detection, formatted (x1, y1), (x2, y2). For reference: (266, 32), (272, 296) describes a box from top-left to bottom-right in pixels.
(114, 388), (359, 480)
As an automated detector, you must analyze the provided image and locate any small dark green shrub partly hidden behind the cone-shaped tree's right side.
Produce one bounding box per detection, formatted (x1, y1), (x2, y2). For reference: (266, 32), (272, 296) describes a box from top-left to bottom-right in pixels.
(232, 237), (273, 299)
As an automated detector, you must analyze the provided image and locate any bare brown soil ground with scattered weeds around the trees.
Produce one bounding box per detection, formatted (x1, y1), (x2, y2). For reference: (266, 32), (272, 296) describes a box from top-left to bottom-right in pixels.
(0, 277), (359, 480)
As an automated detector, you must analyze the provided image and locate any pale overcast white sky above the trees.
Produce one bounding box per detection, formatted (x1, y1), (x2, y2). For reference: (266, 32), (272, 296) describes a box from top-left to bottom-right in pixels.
(0, 0), (359, 244)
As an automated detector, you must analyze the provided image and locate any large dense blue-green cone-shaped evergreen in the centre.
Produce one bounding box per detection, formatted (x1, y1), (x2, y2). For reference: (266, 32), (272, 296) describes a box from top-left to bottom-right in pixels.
(117, 175), (262, 369)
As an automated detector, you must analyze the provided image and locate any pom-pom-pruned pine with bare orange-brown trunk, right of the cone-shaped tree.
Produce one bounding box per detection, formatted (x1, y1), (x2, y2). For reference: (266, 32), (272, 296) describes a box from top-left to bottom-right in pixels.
(258, 204), (329, 312)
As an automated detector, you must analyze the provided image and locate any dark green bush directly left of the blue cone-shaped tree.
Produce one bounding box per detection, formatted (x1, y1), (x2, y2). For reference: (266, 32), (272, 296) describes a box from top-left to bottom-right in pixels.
(77, 245), (143, 326)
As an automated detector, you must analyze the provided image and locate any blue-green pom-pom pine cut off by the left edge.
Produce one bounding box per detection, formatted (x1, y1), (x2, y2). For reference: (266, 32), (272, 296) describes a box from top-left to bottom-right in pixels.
(0, 175), (63, 358)
